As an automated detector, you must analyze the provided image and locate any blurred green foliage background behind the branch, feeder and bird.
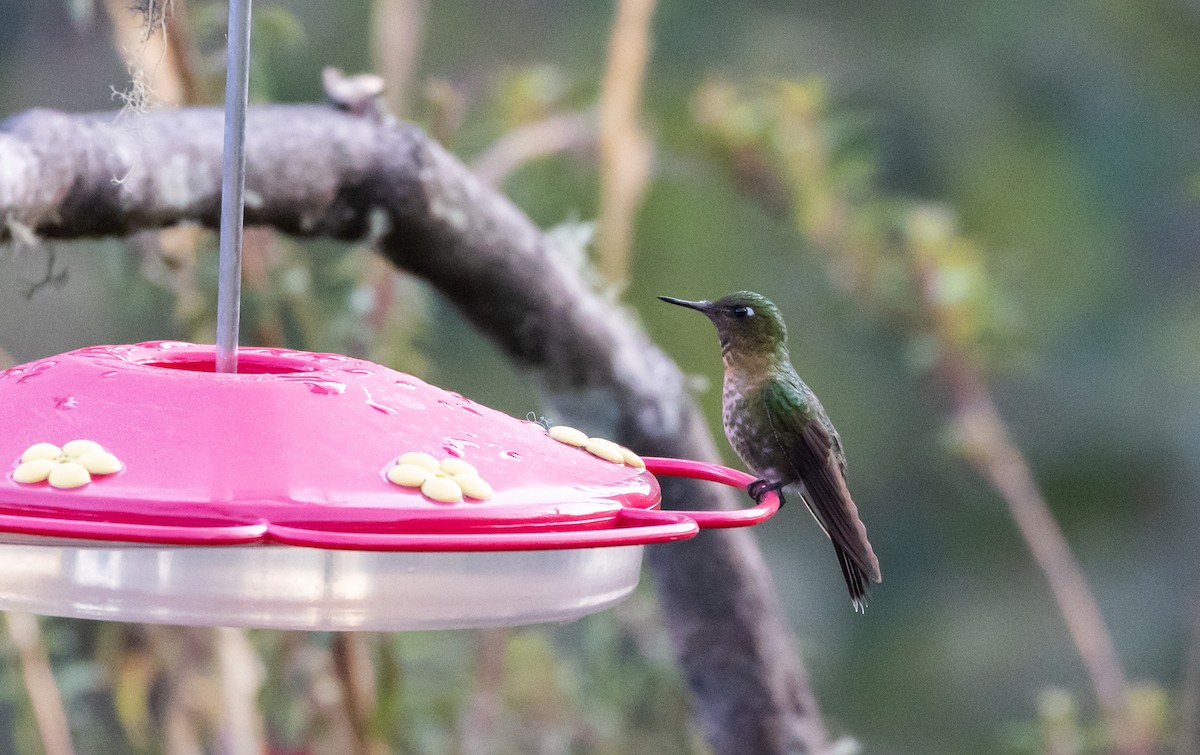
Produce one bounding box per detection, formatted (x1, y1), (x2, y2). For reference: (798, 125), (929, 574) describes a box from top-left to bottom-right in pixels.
(0, 0), (1200, 754)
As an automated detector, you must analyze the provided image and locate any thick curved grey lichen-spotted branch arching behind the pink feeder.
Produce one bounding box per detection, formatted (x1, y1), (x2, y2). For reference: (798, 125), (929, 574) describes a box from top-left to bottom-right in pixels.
(0, 106), (826, 755)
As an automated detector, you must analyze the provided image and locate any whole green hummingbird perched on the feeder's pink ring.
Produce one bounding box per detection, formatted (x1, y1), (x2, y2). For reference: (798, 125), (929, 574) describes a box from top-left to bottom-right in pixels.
(659, 290), (882, 612)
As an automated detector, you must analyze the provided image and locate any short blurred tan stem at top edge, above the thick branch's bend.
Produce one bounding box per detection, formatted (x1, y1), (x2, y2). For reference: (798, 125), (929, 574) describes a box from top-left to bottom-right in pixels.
(371, 0), (428, 115)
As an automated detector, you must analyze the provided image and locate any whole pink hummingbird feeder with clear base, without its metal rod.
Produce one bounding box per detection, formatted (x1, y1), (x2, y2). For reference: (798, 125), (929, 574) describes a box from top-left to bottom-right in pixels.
(0, 342), (778, 629)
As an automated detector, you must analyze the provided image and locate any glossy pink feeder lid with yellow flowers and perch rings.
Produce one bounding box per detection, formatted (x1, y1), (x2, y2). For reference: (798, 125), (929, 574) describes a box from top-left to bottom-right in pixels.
(0, 342), (778, 551)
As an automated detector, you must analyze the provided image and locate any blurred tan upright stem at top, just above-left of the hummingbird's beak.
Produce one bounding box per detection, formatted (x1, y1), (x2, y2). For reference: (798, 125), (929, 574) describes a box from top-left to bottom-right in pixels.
(596, 0), (654, 287)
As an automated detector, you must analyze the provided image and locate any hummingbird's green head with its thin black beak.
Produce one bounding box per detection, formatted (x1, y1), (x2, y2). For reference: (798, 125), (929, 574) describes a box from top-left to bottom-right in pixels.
(659, 290), (787, 362)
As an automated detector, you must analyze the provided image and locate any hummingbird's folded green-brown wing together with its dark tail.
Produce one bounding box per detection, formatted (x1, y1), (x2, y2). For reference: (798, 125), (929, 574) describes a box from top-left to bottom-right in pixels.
(763, 381), (882, 609)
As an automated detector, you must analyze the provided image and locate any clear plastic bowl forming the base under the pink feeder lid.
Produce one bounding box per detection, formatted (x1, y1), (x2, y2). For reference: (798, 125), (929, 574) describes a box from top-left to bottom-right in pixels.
(0, 539), (643, 631)
